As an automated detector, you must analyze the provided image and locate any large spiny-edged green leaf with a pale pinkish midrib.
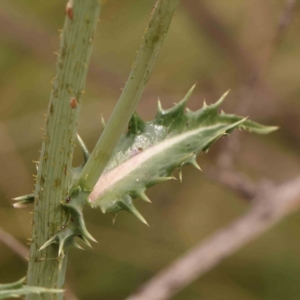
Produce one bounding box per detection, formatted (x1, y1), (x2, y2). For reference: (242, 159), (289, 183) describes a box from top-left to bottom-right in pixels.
(88, 87), (277, 223)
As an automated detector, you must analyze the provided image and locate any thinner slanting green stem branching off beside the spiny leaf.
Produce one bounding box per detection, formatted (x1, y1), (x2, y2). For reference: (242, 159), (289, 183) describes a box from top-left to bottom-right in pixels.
(71, 0), (178, 192)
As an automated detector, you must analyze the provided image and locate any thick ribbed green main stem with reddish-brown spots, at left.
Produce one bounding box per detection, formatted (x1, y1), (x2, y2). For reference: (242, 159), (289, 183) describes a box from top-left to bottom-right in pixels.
(26, 0), (100, 300)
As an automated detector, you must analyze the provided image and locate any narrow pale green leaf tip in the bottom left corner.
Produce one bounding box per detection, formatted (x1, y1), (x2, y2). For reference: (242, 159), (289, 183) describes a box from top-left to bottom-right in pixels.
(0, 278), (64, 299)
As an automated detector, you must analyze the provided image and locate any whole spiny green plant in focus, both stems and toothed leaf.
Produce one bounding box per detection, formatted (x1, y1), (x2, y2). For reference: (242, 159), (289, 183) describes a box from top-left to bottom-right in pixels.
(9, 0), (276, 298)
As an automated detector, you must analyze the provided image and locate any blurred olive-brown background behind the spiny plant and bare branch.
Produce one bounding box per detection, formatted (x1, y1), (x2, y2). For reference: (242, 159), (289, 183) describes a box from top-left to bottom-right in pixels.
(0, 0), (300, 300)
